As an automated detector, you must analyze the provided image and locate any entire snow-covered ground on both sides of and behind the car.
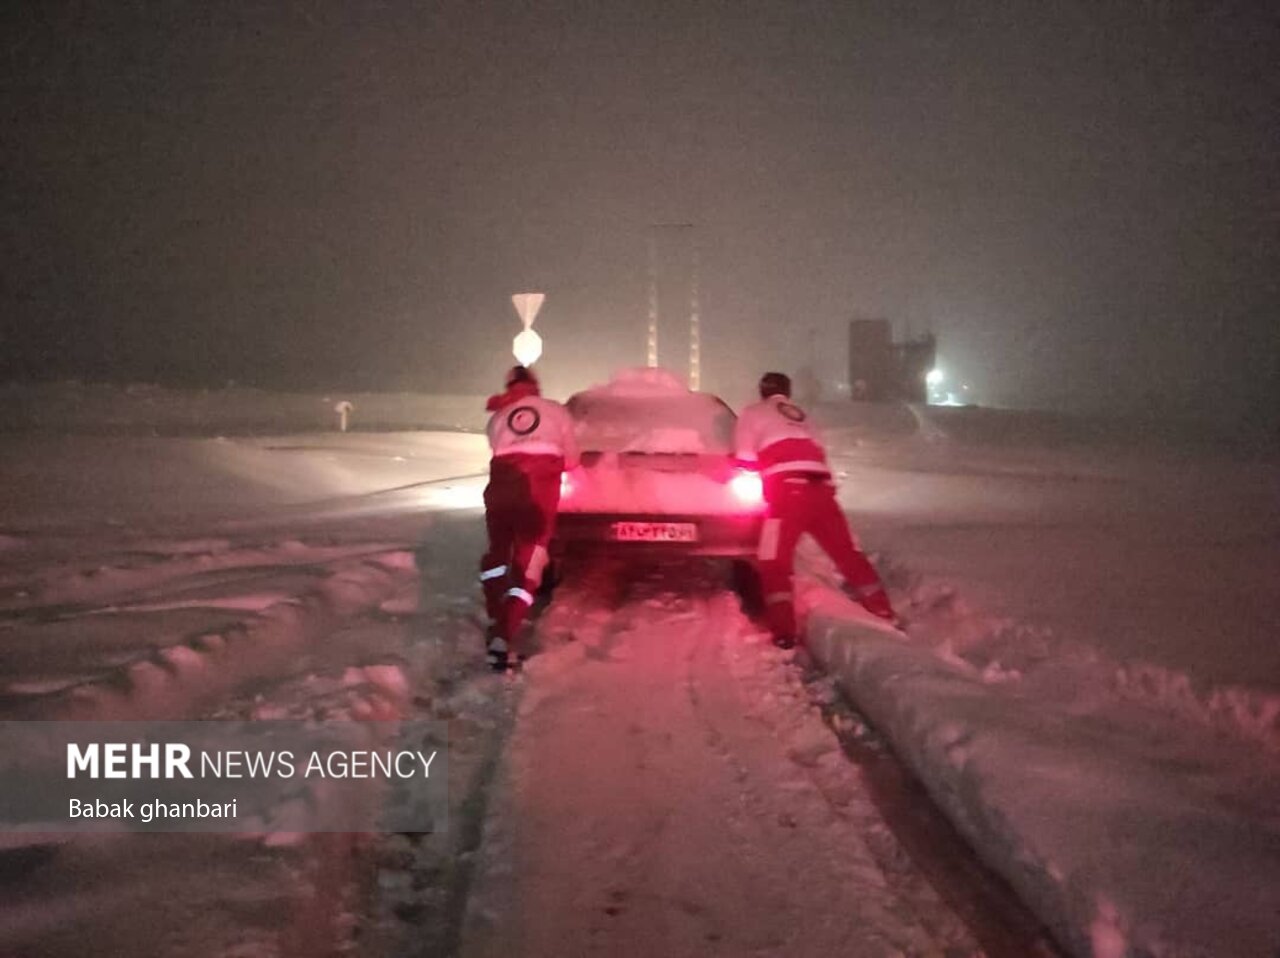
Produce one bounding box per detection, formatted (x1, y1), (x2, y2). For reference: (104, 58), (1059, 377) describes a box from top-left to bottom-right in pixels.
(0, 387), (1280, 958)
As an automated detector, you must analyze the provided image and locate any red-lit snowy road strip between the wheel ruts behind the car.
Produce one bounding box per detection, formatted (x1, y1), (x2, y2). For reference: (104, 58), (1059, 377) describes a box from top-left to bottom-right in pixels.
(462, 566), (1043, 958)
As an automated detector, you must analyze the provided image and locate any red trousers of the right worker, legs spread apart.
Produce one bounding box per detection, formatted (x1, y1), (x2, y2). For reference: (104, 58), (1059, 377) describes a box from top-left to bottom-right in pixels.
(756, 474), (883, 639)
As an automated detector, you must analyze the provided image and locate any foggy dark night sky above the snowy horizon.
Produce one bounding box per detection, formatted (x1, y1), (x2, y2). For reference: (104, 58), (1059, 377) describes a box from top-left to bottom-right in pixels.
(0, 0), (1280, 416)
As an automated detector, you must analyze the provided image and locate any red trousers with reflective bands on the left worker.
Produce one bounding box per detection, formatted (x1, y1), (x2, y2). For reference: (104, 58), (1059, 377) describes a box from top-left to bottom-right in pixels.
(480, 456), (564, 644)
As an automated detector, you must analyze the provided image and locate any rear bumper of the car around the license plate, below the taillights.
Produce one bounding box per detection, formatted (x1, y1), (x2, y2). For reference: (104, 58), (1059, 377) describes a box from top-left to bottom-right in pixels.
(552, 512), (764, 556)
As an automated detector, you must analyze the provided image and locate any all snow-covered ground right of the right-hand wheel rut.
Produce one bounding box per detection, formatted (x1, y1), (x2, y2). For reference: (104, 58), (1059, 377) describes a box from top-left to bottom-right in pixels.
(809, 410), (1280, 958)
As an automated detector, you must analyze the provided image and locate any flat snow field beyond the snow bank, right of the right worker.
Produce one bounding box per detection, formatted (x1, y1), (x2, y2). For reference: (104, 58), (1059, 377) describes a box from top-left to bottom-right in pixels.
(837, 409), (1280, 732)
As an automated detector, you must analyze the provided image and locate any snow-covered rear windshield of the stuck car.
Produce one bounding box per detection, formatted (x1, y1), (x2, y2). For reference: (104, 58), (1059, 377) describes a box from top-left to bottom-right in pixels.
(568, 393), (736, 455)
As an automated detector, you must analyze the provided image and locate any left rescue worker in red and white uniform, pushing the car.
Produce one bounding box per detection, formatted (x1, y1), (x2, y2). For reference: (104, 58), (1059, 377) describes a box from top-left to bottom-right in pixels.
(480, 366), (577, 671)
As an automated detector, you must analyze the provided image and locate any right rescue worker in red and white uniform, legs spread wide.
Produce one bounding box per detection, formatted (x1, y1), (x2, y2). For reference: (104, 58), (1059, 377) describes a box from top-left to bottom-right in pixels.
(735, 373), (899, 648)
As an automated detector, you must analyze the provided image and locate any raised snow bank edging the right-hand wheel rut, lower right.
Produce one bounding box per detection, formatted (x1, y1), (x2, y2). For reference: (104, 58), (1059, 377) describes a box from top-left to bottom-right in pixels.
(801, 583), (1280, 958)
